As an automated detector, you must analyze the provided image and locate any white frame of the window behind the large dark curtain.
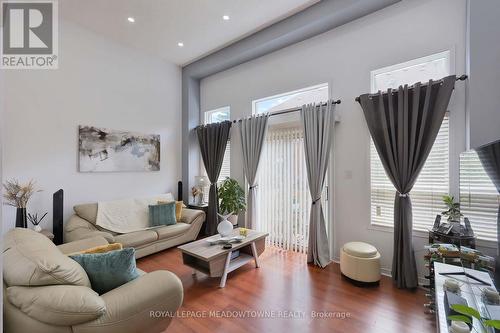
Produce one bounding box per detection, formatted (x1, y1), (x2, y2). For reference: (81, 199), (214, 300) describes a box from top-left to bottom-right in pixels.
(367, 49), (459, 238)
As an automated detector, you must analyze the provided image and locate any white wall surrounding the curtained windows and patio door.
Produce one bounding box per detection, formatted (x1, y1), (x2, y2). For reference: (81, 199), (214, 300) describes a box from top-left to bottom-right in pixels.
(201, 0), (466, 278)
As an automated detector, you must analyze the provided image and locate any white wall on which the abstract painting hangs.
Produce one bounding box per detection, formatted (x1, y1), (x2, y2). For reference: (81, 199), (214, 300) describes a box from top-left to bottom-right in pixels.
(2, 21), (181, 230)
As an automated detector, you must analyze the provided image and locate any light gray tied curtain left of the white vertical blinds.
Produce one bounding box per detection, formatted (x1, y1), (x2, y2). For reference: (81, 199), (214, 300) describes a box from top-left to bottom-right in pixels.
(239, 114), (269, 229)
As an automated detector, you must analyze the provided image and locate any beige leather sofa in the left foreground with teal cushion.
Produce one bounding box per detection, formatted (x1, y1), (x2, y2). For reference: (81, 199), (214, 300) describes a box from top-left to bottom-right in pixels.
(3, 228), (183, 333)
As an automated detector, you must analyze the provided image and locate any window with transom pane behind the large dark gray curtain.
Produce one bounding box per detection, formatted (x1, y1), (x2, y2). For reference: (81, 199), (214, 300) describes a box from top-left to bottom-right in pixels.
(370, 51), (450, 231)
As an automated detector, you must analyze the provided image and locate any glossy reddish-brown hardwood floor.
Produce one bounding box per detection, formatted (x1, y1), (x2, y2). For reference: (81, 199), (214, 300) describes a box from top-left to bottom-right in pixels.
(137, 248), (436, 333)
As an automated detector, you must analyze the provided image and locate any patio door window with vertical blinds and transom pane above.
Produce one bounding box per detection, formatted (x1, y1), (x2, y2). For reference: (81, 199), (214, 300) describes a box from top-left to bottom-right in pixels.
(253, 84), (328, 253)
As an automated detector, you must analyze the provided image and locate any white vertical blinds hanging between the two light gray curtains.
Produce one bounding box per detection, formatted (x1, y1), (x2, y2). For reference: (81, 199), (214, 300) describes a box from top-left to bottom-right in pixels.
(256, 126), (311, 253)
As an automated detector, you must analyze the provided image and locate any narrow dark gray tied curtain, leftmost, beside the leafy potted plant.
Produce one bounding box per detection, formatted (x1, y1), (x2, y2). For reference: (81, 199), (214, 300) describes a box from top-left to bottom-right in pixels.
(196, 121), (231, 236)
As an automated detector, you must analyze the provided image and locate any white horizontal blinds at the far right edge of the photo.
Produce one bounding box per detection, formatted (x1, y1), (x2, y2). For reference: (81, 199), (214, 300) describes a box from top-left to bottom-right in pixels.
(460, 151), (500, 241)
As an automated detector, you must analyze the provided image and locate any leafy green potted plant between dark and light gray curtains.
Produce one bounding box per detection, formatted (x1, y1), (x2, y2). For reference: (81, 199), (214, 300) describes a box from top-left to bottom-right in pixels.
(218, 177), (246, 225)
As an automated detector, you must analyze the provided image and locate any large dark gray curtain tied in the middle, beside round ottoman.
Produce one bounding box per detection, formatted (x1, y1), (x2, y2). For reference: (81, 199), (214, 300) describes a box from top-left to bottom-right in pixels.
(359, 75), (455, 288)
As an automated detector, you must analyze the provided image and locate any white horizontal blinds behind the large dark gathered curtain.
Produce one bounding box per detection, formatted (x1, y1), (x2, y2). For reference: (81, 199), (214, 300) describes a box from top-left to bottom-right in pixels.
(370, 115), (449, 231)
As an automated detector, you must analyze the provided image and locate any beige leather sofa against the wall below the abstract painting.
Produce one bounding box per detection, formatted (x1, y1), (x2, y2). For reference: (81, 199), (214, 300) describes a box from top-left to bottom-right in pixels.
(64, 203), (205, 258)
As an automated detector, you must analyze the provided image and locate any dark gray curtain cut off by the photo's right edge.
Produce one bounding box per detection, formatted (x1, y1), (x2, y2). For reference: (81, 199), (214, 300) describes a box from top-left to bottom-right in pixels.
(476, 142), (500, 254)
